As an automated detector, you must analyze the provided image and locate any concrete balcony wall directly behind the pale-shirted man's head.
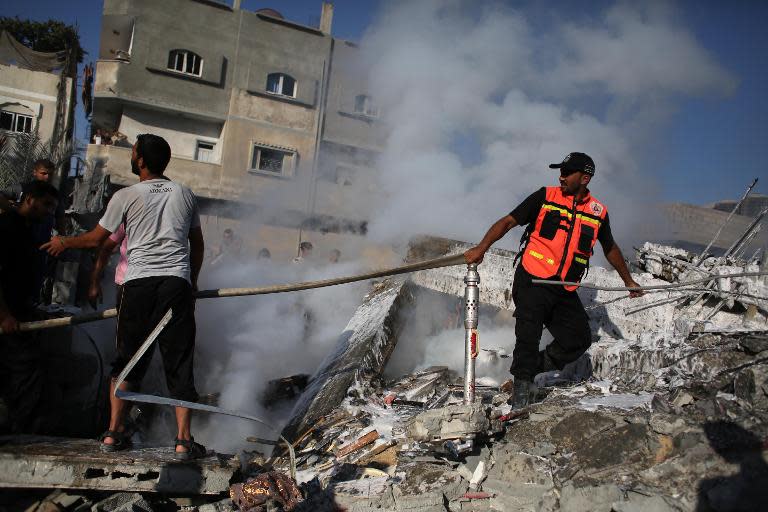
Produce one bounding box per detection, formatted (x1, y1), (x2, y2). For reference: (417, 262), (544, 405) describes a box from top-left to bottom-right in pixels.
(86, 144), (227, 199)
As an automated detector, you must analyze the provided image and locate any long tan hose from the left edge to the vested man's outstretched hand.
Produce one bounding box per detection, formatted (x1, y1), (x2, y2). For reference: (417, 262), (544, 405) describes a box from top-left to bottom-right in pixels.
(0, 254), (465, 334)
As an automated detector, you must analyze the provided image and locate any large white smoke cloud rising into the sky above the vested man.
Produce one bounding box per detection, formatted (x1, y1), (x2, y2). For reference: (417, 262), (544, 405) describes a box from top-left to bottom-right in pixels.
(361, 0), (735, 251)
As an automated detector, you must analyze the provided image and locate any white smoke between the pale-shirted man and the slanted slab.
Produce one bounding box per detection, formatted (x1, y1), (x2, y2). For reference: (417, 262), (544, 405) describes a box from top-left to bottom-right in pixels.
(193, 260), (366, 451)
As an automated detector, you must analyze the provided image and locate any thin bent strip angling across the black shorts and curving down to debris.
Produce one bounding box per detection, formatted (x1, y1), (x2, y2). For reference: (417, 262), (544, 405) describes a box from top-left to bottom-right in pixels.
(115, 309), (296, 480)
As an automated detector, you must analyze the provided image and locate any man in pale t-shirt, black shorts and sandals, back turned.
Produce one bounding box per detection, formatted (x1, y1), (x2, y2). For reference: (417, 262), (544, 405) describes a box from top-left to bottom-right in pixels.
(41, 134), (206, 460)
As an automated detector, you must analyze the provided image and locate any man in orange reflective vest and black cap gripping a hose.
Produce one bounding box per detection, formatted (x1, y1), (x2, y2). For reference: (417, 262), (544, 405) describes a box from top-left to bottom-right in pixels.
(464, 153), (642, 408)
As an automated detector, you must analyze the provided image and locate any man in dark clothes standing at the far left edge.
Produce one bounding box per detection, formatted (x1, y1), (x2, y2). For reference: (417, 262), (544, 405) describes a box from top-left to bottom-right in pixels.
(0, 181), (59, 433)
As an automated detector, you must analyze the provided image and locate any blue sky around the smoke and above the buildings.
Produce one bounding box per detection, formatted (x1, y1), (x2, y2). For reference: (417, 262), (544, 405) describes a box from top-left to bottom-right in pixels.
(0, 0), (768, 204)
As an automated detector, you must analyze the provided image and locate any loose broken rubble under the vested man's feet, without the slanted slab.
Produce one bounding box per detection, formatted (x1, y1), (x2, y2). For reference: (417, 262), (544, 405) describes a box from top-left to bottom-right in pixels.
(254, 245), (768, 511)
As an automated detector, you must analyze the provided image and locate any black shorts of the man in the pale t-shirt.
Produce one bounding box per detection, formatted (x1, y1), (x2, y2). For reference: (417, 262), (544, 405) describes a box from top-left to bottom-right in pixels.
(112, 276), (197, 402)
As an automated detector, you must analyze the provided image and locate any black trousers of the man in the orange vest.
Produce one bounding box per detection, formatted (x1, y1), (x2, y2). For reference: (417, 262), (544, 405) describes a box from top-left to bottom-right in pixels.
(509, 264), (592, 380)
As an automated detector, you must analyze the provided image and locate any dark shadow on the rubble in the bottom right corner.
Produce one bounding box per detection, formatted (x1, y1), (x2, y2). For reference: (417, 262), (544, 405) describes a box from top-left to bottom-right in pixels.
(696, 421), (768, 512)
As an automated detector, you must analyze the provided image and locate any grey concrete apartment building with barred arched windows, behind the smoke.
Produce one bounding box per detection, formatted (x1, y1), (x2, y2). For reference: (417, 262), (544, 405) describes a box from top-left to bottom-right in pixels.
(87, 0), (385, 256)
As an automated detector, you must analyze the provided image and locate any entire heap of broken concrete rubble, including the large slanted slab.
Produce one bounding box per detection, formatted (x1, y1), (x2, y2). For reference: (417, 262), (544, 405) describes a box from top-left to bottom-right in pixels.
(6, 243), (768, 512)
